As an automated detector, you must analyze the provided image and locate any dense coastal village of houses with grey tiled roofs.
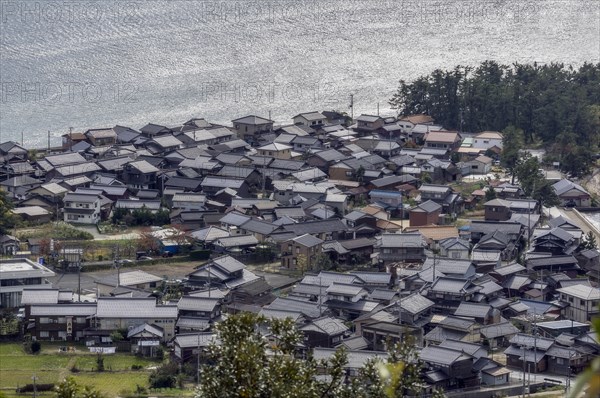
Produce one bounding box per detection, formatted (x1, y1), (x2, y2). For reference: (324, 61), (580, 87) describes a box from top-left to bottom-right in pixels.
(0, 111), (600, 394)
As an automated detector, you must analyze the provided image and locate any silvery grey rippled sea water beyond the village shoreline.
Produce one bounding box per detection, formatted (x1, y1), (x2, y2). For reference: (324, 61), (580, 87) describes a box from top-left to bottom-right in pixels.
(0, 0), (600, 146)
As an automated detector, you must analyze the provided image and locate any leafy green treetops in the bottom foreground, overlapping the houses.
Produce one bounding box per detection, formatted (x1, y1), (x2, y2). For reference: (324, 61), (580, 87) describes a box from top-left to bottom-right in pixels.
(196, 313), (434, 398)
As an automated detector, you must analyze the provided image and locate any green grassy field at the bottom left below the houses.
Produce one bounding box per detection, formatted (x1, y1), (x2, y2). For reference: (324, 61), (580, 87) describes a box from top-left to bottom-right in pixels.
(0, 343), (180, 397)
